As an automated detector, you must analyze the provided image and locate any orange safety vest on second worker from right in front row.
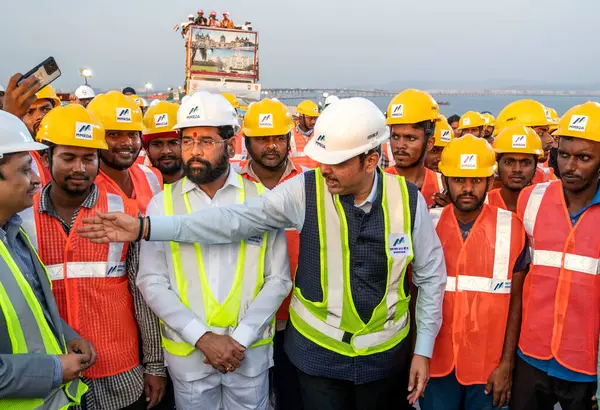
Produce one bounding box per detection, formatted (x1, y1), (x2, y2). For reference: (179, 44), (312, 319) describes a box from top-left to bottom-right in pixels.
(430, 205), (525, 386)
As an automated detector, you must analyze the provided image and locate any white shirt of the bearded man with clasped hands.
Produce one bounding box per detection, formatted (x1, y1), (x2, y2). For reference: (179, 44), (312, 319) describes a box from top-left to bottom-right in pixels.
(137, 169), (292, 381)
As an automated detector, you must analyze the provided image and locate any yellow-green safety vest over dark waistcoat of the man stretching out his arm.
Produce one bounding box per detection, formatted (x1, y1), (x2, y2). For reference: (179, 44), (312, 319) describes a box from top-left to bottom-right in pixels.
(290, 169), (413, 357)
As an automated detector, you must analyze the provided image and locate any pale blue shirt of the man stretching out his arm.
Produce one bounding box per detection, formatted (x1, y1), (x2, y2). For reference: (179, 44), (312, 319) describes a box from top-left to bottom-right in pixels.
(151, 174), (446, 357)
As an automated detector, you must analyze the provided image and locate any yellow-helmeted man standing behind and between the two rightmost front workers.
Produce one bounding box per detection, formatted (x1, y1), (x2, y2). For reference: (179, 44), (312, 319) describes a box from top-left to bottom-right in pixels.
(488, 124), (544, 212)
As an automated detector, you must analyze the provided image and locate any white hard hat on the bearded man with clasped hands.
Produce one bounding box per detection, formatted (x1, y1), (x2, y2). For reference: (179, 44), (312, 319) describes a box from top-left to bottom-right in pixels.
(173, 91), (240, 133)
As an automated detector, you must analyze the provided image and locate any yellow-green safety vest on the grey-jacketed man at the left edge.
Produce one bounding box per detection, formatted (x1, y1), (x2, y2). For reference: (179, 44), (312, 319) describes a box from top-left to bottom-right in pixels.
(0, 231), (88, 410)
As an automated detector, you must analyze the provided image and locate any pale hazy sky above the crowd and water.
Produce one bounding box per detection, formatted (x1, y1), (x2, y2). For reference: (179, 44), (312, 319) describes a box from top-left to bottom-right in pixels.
(0, 0), (600, 91)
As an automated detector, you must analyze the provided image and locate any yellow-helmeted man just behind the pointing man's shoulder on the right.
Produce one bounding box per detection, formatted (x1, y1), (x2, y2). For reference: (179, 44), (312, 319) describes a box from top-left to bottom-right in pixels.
(385, 89), (442, 206)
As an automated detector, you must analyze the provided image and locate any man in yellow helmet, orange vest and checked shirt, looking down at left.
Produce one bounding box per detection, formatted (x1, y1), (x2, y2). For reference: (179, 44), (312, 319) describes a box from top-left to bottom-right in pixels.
(29, 104), (166, 410)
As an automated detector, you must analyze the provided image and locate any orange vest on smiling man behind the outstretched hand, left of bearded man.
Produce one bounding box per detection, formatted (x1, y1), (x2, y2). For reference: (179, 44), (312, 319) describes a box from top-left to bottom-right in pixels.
(96, 164), (163, 215)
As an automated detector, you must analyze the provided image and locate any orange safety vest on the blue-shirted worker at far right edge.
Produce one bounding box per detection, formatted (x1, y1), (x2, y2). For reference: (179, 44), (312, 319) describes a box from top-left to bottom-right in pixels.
(517, 181), (600, 375)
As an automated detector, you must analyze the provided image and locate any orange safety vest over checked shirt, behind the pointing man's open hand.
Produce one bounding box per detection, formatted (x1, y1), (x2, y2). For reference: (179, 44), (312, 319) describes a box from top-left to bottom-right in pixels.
(33, 188), (140, 378)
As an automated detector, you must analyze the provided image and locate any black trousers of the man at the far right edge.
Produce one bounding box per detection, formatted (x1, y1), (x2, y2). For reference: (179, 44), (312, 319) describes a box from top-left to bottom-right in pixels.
(510, 355), (596, 410)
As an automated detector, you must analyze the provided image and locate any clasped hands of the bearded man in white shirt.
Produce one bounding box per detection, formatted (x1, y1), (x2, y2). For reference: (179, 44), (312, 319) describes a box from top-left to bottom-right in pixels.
(196, 332), (246, 374)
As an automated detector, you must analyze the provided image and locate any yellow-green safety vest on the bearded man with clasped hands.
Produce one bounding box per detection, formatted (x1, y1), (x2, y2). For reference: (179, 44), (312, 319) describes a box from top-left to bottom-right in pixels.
(161, 174), (275, 356)
